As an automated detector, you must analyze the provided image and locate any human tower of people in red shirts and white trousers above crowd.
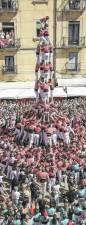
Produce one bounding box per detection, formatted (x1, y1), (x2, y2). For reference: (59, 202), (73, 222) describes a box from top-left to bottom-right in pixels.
(34, 16), (54, 104)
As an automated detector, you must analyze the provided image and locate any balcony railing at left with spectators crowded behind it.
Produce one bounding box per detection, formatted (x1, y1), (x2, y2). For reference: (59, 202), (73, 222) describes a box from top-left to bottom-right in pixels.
(0, 38), (20, 49)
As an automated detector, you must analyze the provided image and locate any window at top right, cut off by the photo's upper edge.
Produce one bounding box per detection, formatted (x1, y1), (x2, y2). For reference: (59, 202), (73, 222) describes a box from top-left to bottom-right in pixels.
(69, 0), (80, 10)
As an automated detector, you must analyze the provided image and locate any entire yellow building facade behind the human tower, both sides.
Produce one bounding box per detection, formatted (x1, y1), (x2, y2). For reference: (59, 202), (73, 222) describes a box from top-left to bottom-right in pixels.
(0, 0), (86, 81)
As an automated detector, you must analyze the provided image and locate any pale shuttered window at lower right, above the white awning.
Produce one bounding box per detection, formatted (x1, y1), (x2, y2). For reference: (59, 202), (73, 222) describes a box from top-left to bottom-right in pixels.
(67, 52), (78, 71)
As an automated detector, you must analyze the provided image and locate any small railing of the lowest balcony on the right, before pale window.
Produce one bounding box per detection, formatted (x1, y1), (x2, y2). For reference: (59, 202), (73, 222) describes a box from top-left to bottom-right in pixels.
(65, 62), (80, 72)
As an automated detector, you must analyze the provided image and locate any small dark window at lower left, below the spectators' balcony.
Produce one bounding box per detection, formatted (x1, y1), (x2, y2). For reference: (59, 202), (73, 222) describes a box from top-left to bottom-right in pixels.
(5, 56), (15, 73)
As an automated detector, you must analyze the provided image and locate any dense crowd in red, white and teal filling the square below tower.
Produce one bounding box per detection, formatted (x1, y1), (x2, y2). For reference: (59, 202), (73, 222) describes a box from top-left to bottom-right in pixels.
(0, 98), (86, 225)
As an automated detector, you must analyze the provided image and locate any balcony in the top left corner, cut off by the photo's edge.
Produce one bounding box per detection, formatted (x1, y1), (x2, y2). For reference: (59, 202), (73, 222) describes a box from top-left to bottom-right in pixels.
(0, 0), (18, 13)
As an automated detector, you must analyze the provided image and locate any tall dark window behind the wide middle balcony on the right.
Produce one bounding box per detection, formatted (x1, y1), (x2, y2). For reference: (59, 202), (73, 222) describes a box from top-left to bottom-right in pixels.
(68, 21), (80, 45)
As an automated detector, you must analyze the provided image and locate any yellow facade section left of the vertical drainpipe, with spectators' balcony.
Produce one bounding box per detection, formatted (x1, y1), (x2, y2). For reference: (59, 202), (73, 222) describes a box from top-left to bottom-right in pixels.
(0, 0), (53, 81)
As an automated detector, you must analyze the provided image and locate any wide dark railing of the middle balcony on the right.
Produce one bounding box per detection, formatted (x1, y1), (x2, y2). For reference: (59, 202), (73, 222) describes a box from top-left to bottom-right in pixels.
(60, 37), (85, 48)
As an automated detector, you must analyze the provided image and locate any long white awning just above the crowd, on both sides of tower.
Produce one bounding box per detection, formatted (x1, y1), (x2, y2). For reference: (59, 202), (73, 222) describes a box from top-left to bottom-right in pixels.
(0, 87), (86, 99)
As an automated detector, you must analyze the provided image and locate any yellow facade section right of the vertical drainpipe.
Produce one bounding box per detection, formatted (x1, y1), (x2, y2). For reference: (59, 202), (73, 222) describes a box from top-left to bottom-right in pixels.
(56, 0), (86, 77)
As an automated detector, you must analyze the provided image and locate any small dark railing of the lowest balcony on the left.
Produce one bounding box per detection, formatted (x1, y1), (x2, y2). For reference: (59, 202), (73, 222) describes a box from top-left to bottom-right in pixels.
(2, 65), (17, 74)
